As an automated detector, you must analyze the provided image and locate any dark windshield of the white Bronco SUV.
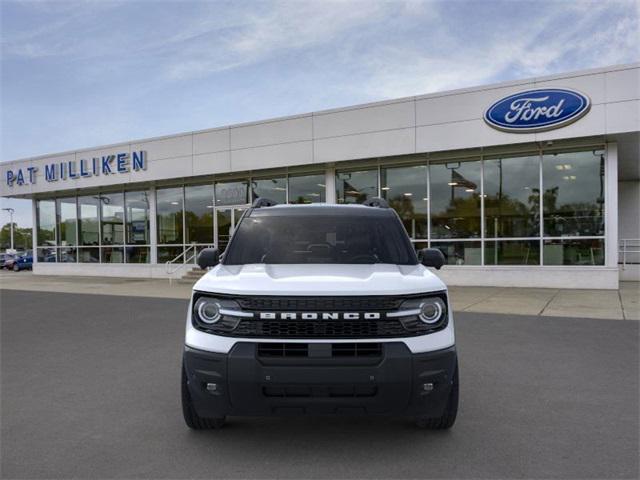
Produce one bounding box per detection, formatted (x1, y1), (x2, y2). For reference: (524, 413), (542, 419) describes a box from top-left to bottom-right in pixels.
(223, 212), (418, 265)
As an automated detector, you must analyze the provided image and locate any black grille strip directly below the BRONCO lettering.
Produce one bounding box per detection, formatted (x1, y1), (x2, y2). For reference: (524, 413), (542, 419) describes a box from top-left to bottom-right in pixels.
(232, 319), (408, 338)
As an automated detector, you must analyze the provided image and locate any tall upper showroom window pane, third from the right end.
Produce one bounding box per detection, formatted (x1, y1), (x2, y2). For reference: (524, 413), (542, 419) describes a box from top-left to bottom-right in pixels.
(429, 160), (481, 238)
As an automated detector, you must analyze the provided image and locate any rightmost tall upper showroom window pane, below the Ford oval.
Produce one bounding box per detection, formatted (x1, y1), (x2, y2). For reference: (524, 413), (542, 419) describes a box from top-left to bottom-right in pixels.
(542, 150), (605, 237)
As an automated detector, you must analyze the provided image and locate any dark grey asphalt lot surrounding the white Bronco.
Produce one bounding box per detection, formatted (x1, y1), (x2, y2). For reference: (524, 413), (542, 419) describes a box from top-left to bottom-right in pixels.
(0, 290), (640, 478)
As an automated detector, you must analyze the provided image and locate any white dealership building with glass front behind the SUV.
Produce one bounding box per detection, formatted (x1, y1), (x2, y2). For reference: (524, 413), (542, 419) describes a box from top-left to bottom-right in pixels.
(0, 64), (640, 289)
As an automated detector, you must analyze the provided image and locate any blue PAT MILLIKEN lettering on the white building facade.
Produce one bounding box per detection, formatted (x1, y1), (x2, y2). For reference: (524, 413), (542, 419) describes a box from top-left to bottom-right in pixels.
(4, 150), (147, 187)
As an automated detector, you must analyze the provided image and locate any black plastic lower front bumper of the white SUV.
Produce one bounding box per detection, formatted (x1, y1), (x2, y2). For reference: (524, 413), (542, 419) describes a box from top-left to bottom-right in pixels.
(184, 342), (457, 418)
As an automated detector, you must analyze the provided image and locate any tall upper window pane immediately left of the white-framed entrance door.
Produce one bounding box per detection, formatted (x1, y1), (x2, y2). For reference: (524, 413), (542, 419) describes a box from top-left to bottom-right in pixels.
(184, 185), (213, 244)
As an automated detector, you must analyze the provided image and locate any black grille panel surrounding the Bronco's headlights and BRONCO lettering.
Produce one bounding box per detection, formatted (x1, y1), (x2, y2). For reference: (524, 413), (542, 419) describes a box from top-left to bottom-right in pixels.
(194, 292), (447, 339)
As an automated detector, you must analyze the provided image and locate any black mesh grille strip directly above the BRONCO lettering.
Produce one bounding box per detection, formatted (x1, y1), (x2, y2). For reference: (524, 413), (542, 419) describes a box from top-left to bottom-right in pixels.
(234, 297), (406, 312)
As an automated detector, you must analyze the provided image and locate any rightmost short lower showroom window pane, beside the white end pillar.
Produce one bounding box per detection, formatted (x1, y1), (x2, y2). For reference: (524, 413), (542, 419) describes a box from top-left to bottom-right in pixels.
(542, 238), (604, 265)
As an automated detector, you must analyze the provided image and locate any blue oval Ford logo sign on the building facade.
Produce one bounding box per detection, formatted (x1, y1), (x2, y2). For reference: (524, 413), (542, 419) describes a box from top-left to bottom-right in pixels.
(484, 88), (591, 133)
